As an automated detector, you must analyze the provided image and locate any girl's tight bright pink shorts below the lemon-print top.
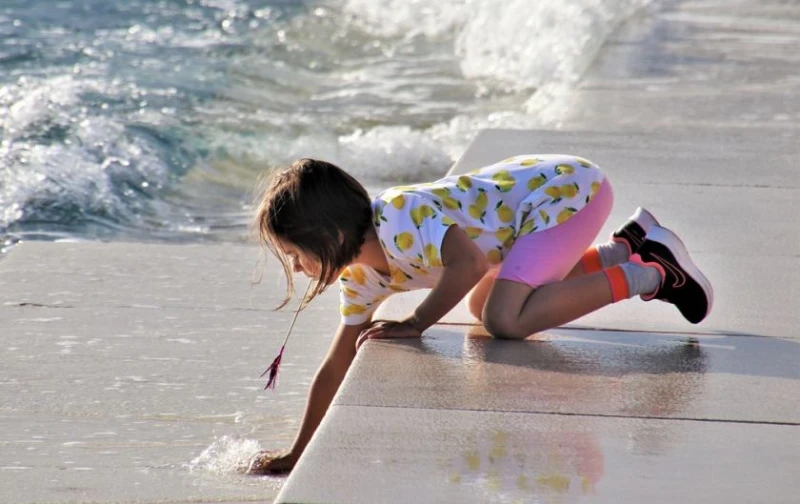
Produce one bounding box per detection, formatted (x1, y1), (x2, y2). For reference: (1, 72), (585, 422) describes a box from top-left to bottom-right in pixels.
(497, 179), (614, 287)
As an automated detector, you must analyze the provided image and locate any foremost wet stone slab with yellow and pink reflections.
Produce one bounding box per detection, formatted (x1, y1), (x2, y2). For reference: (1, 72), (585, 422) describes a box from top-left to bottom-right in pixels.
(279, 406), (800, 504)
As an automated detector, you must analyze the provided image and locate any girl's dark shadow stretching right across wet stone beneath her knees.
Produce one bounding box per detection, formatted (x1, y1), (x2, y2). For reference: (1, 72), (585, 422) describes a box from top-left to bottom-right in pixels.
(412, 326), (800, 380)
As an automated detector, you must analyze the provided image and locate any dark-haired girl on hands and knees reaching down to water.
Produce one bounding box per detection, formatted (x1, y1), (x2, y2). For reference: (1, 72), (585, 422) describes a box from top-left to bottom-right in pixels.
(250, 155), (713, 473)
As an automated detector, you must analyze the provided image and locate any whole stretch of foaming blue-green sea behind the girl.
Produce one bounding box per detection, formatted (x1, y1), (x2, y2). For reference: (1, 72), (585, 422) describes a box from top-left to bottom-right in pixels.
(0, 0), (648, 249)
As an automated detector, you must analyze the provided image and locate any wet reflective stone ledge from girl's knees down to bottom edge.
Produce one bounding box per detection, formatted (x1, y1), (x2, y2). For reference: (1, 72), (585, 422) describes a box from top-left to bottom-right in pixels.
(277, 327), (800, 504)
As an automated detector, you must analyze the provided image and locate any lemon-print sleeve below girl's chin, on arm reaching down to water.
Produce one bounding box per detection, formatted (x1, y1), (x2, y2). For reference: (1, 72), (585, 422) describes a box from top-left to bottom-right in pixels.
(339, 265), (392, 325)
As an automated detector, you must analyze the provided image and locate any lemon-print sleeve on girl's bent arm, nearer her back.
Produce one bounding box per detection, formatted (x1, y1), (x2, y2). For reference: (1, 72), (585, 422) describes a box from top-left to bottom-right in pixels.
(379, 193), (454, 268)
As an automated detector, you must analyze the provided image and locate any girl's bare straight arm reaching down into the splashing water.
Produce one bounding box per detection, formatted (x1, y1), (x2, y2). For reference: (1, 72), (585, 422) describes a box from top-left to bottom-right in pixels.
(248, 321), (370, 474)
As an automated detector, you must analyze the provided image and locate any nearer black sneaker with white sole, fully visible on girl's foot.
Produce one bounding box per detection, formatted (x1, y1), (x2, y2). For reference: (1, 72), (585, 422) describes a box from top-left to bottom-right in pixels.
(634, 226), (714, 324)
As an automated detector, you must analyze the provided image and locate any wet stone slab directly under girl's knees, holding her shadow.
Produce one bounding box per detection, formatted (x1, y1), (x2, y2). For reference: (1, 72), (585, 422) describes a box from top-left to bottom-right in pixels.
(335, 326), (800, 426)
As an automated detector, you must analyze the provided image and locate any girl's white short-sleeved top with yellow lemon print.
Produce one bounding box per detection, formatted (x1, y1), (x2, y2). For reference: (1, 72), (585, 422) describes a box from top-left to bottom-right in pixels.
(339, 155), (603, 325)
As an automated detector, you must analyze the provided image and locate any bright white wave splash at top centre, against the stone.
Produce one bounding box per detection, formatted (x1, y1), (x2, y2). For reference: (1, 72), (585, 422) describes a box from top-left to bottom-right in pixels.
(345, 0), (650, 95)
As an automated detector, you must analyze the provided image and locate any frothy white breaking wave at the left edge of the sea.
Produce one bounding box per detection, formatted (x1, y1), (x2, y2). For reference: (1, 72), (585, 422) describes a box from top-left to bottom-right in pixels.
(0, 76), (175, 229)
